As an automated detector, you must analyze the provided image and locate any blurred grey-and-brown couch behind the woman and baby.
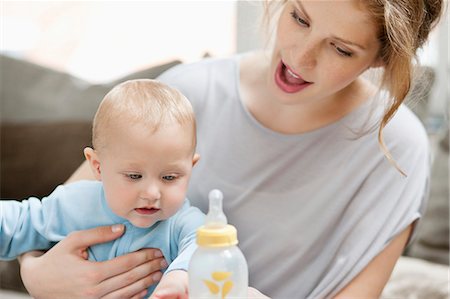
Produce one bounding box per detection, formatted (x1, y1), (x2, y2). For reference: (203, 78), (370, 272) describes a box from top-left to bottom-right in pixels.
(0, 56), (449, 299)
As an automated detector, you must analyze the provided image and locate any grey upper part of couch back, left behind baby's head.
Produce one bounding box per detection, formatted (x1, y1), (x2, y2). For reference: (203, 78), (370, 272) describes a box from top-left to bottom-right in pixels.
(0, 55), (180, 123)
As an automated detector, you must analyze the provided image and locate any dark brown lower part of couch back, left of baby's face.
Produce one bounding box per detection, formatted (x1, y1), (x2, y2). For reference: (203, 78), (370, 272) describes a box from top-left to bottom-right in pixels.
(0, 122), (91, 199)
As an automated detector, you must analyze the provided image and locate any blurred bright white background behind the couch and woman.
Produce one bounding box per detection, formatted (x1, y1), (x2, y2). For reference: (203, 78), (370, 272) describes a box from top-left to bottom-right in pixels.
(0, 0), (450, 122)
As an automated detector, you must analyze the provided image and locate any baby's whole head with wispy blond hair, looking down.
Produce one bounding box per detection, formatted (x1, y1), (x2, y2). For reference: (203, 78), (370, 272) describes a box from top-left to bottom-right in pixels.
(84, 79), (198, 227)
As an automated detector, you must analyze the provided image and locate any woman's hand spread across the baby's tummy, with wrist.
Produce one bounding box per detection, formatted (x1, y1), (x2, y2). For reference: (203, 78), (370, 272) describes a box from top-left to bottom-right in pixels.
(19, 225), (167, 299)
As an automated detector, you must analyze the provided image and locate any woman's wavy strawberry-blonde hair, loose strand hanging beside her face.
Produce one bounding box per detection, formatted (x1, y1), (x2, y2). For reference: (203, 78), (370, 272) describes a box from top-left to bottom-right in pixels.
(264, 0), (443, 175)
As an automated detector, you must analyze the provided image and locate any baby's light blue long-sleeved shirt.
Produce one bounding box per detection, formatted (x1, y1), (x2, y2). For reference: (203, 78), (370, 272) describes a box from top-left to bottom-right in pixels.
(0, 181), (204, 294)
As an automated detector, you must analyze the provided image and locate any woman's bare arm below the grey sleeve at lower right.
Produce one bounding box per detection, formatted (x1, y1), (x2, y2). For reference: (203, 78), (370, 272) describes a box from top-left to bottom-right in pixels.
(335, 224), (414, 299)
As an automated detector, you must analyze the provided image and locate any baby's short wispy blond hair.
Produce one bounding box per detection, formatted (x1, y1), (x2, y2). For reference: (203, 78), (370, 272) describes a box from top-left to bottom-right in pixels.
(92, 79), (196, 149)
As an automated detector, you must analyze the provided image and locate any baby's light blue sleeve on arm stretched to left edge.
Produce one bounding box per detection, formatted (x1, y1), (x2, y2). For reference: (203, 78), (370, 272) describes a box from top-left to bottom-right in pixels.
(0, 181), (103, 260)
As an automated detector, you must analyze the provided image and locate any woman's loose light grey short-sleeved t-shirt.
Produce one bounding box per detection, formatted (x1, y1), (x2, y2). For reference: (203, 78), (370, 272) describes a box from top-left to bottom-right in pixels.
(159, 56), (429, 299)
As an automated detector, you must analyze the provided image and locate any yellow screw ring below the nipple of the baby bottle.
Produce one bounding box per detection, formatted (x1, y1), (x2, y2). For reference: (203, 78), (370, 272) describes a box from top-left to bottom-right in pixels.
(197, 224), (238, 247)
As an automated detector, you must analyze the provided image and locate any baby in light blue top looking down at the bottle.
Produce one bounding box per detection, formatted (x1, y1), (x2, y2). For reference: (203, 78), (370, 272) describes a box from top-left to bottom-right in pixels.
(0, 79), (204, 298)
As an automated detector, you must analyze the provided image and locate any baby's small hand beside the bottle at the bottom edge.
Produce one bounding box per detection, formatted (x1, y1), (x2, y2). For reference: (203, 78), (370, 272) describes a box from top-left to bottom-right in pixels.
(150, 270), (188, 299)
